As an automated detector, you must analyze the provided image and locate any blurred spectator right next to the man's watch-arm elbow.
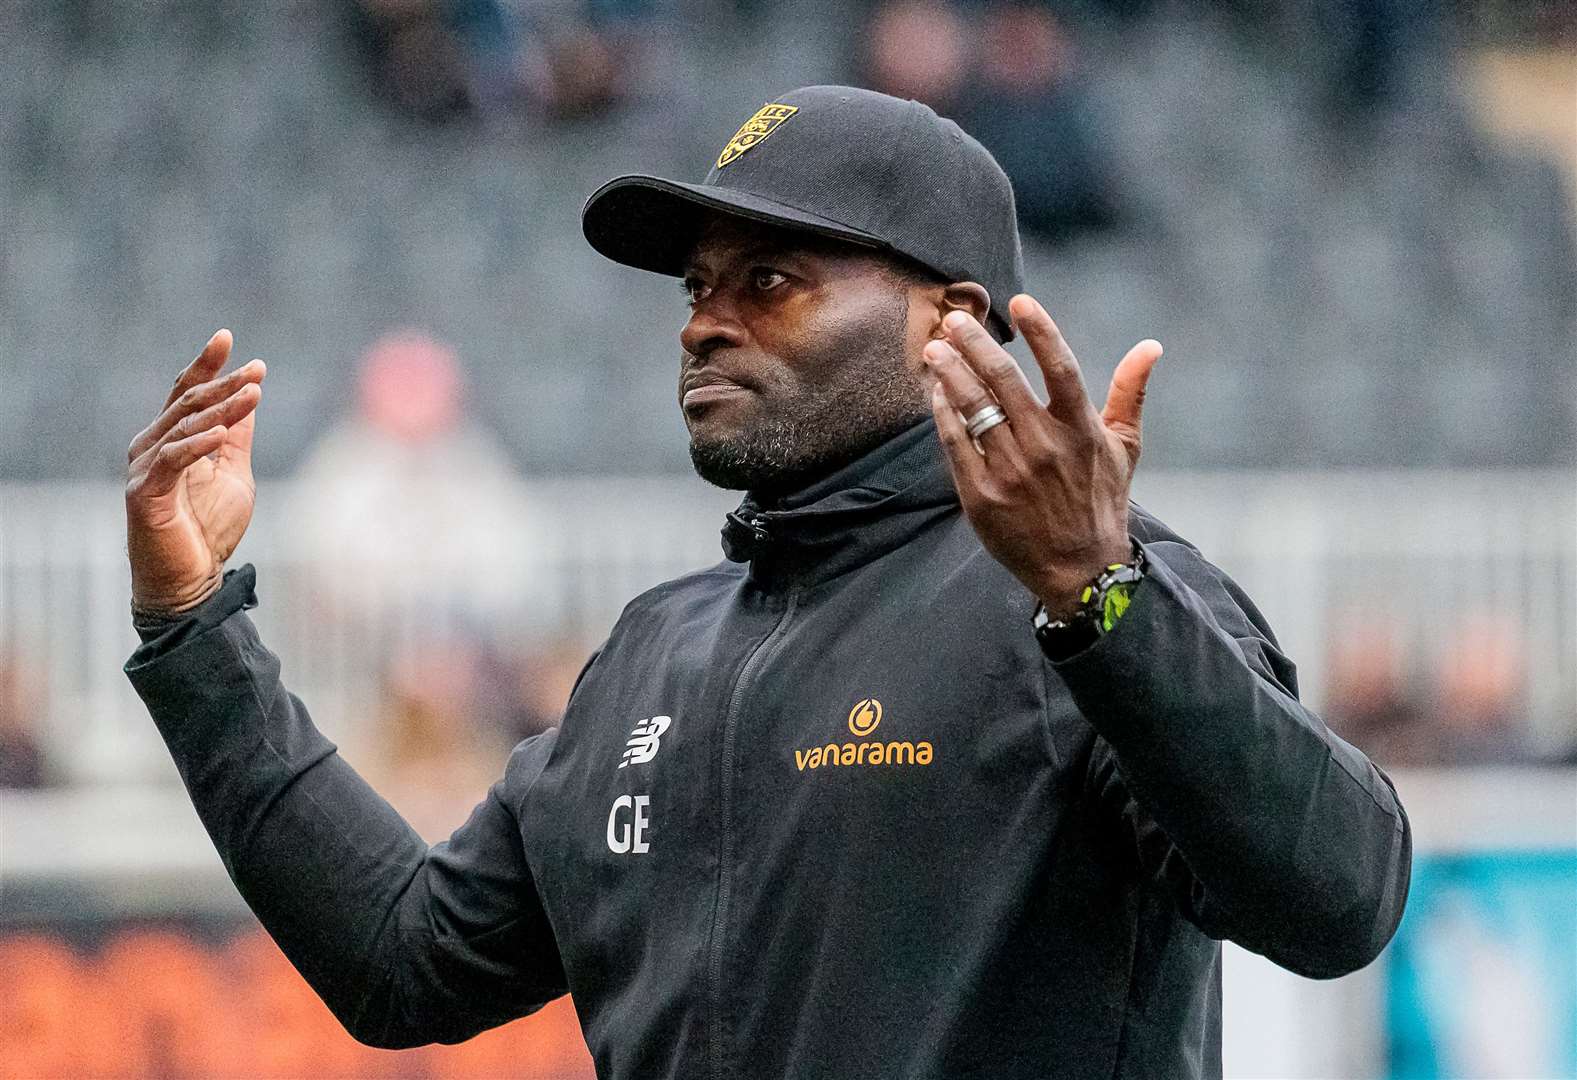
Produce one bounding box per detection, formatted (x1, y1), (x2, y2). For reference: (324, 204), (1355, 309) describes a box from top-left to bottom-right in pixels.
(1325, 610), (1441, 768)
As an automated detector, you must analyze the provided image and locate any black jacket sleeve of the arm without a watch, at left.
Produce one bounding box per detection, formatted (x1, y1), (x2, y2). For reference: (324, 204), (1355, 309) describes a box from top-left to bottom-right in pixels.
(125, 566), (566, 1048)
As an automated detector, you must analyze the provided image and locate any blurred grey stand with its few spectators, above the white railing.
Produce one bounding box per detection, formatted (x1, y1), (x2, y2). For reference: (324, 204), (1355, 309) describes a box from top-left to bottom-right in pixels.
(0, 0), (1577, 481)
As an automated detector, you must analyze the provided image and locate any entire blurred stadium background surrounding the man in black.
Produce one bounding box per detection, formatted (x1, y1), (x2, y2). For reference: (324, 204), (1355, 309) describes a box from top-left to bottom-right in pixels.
(0, 0), (1577, 1078)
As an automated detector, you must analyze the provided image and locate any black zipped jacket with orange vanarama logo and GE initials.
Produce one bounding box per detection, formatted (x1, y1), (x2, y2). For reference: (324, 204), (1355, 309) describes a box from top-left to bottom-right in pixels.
(126, 423), (1411, 1080)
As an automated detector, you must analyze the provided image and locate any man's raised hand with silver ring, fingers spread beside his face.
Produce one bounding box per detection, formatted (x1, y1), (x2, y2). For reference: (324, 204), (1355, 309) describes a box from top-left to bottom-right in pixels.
(924, 295), (1161, 618)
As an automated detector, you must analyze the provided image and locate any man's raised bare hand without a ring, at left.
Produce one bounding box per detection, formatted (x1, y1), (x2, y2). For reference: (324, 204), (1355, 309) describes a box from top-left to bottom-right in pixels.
(126, 330), (267, 615)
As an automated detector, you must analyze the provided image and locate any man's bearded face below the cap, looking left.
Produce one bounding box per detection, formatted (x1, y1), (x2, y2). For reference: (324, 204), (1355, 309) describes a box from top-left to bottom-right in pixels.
(680, 216), (940, 493)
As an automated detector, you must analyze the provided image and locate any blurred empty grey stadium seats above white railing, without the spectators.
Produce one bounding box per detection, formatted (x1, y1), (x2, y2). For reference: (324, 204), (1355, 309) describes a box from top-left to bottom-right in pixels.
(0, 0), (1577, 479)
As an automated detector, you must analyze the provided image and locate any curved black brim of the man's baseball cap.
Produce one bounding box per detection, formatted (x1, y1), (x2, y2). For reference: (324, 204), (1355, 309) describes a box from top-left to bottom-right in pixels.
(580, 175), (886, 277)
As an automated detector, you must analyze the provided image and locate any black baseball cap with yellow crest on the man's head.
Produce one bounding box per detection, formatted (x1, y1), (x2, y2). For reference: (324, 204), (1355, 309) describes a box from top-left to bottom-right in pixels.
(580, 87), (1023, 341)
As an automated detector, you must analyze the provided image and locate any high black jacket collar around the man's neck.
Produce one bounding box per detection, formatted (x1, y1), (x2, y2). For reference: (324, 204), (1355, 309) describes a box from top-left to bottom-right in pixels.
(722, 419), (959, 591)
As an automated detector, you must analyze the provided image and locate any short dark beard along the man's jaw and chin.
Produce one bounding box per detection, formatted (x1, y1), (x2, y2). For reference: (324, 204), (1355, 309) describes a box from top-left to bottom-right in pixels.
(691, 293), (930, 497)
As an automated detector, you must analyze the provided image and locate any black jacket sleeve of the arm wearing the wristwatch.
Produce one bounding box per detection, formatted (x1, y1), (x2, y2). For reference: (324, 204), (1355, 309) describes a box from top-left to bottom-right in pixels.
(1052, 530), (1411, 978)
